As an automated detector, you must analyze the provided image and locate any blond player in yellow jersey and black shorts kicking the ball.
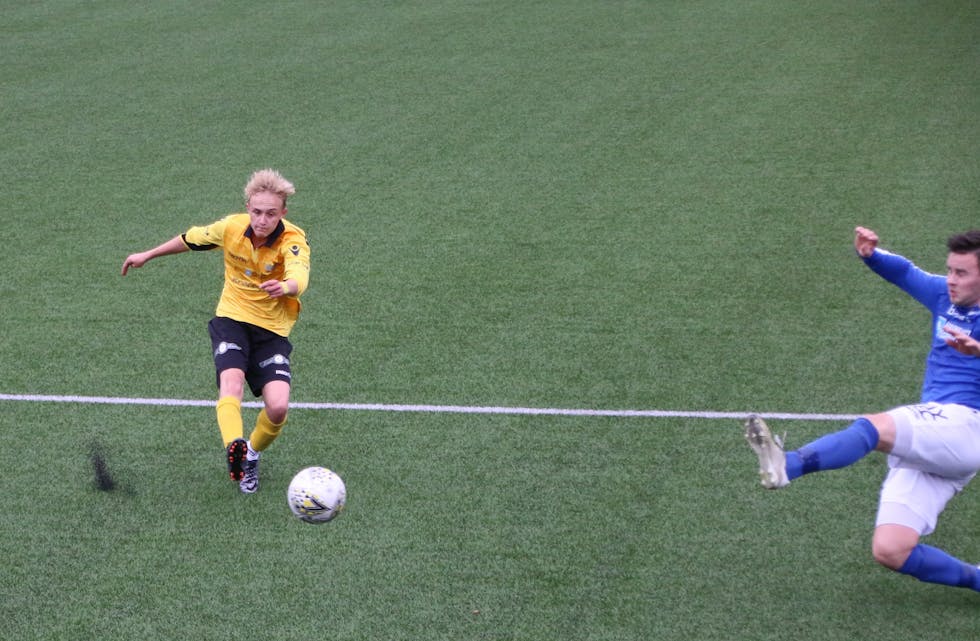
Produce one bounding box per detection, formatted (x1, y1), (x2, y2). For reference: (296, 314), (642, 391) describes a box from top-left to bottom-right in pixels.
(122, 169), (310, 494)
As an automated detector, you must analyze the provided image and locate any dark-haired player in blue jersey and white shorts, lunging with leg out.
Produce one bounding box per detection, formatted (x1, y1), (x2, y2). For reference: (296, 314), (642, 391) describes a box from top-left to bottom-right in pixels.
(745, 227), (980, 592)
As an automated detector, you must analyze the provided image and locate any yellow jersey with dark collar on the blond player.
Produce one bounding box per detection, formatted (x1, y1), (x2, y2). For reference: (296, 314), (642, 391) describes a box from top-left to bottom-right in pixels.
(181, 214), (310, 336)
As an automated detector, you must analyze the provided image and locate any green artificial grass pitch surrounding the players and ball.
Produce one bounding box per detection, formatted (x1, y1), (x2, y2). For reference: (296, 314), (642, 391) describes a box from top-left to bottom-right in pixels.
(0, 0), (980, 641)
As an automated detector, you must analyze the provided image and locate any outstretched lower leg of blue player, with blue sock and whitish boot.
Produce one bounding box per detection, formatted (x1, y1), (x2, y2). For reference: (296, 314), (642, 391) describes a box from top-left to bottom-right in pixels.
(745, 414), (895, 489)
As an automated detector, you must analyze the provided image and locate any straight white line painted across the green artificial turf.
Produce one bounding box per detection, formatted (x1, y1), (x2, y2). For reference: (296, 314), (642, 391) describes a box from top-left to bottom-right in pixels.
(0, 393), (857, 421)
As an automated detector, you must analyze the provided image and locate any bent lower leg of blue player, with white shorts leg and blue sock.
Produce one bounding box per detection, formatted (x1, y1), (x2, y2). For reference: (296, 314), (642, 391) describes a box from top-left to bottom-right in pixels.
(871, 470), (980, 591)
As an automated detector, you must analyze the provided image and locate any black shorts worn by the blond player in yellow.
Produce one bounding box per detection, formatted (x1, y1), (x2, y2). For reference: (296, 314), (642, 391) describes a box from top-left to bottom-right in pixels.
(208, 316), (293, 396)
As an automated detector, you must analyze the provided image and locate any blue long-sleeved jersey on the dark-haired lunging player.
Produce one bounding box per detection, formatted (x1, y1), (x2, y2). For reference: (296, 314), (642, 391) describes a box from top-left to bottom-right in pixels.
(864, 249), (980, 409)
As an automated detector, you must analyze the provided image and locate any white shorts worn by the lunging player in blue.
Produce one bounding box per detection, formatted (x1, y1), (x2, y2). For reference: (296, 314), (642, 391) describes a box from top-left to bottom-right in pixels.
(876, 403), (980, 535)
